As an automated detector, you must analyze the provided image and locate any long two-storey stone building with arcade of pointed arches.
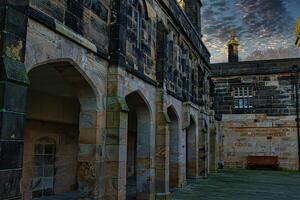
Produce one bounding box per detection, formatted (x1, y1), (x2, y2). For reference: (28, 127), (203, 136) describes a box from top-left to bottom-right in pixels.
(0, 0), (219, 200)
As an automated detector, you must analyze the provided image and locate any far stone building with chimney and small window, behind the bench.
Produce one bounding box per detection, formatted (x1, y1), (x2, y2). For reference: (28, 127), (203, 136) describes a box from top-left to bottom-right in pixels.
(212, 32), (300, 170)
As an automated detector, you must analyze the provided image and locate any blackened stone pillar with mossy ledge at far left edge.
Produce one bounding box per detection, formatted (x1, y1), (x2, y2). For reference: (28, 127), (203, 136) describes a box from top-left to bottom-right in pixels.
(0, 0), (29, 199)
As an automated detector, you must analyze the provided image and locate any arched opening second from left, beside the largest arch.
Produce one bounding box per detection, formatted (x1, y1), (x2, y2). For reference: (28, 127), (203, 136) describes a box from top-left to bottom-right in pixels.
(126, 92), (151, 200)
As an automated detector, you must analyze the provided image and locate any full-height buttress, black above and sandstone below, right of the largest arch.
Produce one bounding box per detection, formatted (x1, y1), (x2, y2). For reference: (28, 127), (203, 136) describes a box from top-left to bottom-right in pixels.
(104, 0), (129, 200)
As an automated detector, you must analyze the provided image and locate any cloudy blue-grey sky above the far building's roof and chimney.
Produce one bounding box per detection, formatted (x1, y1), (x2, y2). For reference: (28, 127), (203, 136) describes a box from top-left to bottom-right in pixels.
(202, 0), (300, 63)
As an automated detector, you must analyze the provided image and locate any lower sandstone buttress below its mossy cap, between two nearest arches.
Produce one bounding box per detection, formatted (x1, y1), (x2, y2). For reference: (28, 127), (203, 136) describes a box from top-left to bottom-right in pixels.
(104, 98), (128, 200)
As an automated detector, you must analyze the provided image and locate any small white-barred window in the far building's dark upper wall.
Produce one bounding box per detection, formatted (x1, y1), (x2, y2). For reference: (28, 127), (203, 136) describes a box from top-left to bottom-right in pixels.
(234, 87), (253, 109)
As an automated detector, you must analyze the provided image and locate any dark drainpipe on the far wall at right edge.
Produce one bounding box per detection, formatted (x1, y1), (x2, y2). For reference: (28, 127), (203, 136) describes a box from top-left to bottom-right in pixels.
(293, 65), (300, 171)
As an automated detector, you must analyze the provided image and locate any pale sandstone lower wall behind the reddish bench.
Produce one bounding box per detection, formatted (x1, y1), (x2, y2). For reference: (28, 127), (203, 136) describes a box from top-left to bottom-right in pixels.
(221, 114), (298, 170)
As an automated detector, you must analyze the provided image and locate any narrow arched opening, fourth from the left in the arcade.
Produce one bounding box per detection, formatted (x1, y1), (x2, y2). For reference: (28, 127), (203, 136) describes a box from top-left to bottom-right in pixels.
(186, 116), (197, 178)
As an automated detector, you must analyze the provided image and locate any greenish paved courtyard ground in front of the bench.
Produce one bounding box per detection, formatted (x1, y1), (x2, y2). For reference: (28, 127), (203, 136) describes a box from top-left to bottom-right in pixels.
(172, 170), (300, 200)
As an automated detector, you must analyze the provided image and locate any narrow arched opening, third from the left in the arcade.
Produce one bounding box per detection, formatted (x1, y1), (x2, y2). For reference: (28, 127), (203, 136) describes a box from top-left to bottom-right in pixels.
(167, 106), (180, 188)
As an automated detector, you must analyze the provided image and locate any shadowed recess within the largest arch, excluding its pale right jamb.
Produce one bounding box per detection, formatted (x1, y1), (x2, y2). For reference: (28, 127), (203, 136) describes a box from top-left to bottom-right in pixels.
(22, 62), (96, 199)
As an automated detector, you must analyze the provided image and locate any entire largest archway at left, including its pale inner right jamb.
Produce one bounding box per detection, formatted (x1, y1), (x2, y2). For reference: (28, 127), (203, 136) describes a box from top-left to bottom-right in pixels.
(22, 61), (104, 198)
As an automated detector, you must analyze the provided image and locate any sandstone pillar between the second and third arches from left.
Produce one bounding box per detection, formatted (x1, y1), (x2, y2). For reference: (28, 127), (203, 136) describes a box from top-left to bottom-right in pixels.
(155, 88), (170, 200)
